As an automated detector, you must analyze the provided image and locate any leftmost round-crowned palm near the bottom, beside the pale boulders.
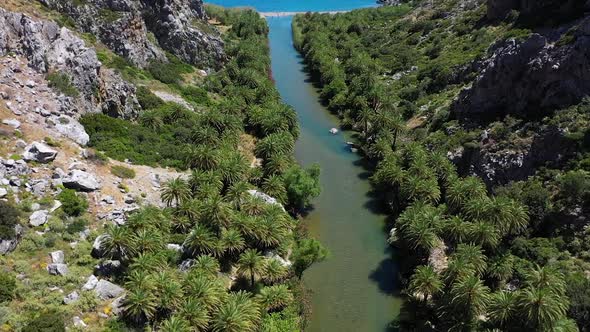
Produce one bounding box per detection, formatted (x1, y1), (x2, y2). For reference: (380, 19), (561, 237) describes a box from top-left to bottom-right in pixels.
(123, 287), (158, 323)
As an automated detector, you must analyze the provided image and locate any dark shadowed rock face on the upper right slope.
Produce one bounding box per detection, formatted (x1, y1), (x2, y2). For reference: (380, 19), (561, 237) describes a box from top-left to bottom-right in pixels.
(452, 18), (590, 121)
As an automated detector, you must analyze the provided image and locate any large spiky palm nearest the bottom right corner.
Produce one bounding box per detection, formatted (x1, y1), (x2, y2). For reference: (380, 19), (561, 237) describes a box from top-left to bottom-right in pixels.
(517, 286), (569, 330)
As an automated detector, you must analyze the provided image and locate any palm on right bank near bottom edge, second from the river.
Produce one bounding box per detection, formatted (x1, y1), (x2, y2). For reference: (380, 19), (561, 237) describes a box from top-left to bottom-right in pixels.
(450, 275), (490, 322)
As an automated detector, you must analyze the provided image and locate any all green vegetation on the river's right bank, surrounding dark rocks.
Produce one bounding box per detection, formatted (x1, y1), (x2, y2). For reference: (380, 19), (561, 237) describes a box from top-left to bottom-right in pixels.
(293, 0), (590, 331)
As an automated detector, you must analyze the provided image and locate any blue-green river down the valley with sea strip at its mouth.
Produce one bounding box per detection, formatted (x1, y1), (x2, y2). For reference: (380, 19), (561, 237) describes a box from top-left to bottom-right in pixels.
(208, 0), (400, 332)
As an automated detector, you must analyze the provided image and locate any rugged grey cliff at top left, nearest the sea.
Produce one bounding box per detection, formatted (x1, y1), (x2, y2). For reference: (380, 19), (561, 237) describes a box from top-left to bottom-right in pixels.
(39, 0), (225, 68)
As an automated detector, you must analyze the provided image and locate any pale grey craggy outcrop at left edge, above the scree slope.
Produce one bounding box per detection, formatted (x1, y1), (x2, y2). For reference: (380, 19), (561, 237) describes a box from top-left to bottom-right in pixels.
(0, 8), (140, 118)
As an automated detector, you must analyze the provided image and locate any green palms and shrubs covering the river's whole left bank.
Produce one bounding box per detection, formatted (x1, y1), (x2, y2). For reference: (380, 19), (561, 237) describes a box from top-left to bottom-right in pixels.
(75, 6), (327, 331)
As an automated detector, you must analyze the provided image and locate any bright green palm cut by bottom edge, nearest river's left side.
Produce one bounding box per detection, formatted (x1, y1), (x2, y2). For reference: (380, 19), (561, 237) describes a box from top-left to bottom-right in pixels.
(212, 291), (260, 332)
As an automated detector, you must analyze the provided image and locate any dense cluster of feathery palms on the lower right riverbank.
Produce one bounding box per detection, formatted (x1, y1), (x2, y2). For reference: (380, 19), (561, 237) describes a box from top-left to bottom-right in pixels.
(372, 144), (577, 331)
